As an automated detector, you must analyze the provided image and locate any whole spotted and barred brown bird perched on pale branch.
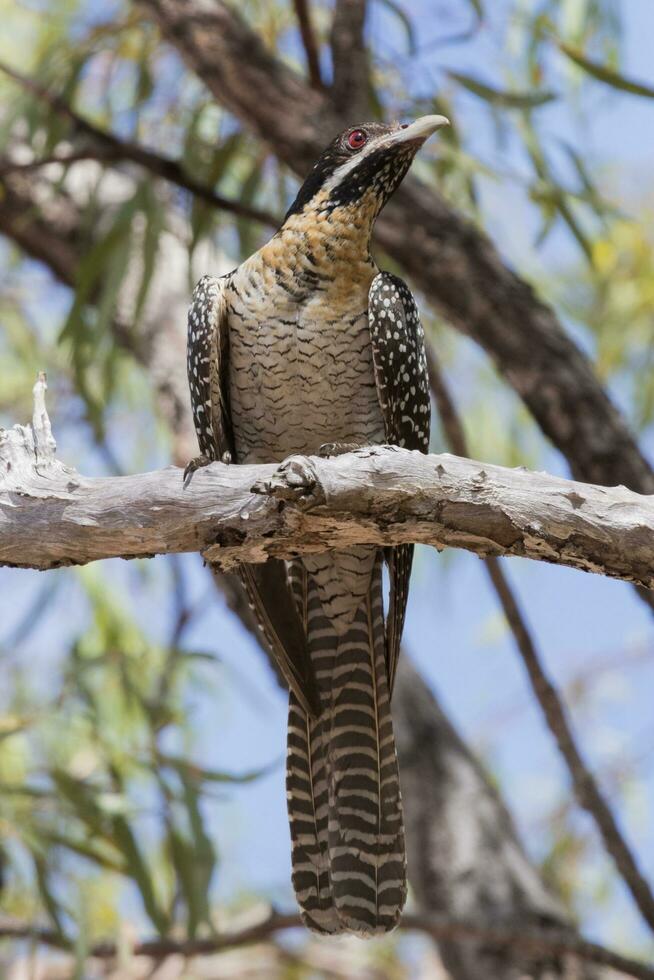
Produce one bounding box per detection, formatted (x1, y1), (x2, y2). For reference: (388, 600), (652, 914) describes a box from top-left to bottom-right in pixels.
(185, 115), (448, 938)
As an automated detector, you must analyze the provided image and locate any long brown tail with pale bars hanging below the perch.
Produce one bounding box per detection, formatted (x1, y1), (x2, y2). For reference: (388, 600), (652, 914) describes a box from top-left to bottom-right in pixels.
(286, 549), (406, 936)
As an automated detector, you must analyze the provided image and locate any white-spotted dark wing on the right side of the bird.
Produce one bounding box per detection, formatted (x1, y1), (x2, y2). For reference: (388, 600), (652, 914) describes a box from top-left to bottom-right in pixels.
(368, 272), (431, 692)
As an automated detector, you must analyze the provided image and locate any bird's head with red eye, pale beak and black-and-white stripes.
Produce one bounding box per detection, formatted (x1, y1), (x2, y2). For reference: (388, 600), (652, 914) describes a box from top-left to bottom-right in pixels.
(284, 116), (449, 231)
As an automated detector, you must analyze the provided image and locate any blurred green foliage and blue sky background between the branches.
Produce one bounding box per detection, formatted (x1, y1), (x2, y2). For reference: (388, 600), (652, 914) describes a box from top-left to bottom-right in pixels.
(0, 0), (654, 975)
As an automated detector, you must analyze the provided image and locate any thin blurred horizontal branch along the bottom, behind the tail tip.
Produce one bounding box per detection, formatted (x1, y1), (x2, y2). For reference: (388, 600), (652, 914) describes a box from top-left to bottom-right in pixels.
(0, 912), (654, 980)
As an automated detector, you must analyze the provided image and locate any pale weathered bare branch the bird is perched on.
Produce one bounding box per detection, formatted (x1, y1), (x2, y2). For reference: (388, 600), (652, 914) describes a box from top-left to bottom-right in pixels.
(0, 382), (654, 587)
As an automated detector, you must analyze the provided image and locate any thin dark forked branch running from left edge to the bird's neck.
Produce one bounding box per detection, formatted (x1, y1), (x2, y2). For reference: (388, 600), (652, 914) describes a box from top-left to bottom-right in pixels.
(0, 62), (281, 228)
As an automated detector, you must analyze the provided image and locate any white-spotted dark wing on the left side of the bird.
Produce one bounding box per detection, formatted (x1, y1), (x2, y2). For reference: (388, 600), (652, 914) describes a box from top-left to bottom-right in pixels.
(187, 276), (318, 714)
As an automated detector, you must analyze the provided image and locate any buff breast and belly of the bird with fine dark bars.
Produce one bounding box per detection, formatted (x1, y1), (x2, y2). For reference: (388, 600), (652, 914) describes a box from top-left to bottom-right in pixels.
(229, 233), (384, 463)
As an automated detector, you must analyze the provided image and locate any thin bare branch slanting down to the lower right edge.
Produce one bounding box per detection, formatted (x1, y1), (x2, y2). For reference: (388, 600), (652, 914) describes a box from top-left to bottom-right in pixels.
(427, 345), (654, 929)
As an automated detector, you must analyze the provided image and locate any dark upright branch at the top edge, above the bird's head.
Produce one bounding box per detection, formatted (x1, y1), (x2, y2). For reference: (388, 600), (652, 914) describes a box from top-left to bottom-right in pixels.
(330, 0), (370, 122)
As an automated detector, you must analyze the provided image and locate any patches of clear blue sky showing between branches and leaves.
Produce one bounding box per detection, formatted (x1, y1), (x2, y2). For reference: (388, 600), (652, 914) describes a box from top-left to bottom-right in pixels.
(0, 0), (654, 956)
